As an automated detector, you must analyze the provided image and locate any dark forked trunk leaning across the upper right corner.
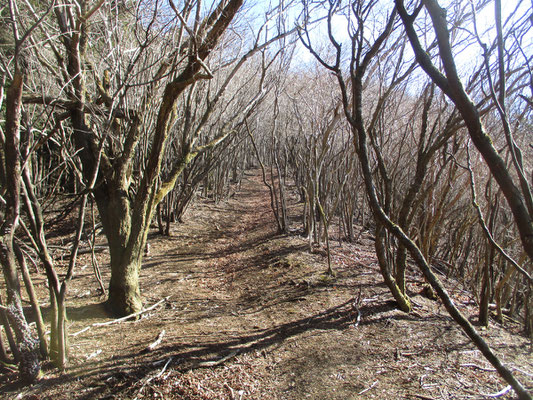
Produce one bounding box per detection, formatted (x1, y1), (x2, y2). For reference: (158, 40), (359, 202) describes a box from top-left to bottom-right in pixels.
(396, 0), (533, 266)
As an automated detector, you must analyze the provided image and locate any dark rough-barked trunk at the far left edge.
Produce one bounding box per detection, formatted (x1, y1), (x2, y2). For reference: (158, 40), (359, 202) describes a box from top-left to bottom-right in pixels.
(0, 1), (54, 383)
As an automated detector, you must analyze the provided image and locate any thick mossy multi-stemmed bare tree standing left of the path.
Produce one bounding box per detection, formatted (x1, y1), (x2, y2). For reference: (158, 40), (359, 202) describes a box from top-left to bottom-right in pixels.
(20, 0), (251, 315)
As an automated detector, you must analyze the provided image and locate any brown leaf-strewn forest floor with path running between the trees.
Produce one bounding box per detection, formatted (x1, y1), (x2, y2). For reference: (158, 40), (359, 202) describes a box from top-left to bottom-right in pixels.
(0, 170), (533, 400)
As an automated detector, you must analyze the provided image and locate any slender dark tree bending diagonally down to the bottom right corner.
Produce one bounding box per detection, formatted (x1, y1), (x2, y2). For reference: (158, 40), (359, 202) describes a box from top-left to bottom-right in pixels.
(304, 1), (531, 399)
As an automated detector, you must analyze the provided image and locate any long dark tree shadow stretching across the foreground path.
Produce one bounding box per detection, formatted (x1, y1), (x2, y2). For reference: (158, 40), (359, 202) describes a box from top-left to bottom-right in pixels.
(12, 299), (450, 399)
